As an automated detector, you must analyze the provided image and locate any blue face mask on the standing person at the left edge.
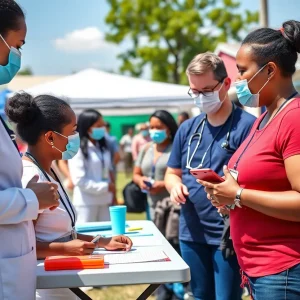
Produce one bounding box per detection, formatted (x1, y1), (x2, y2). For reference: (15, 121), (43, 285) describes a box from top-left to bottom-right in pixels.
(0, 34), (21, 84)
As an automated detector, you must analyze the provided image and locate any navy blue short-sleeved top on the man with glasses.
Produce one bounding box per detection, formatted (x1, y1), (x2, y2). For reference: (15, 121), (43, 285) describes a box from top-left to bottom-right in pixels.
(168, 107), (255, 245)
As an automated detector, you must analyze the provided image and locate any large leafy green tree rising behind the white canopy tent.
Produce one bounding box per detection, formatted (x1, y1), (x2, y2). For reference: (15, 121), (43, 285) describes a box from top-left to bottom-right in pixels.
(106, 0), (258, 83)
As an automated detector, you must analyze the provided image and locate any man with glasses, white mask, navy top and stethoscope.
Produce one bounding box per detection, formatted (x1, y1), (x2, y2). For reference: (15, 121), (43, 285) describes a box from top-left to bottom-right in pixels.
(165, 53), (255, 300)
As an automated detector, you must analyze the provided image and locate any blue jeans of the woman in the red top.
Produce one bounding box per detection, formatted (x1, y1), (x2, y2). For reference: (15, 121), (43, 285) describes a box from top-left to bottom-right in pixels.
(248, 264), (300, 300)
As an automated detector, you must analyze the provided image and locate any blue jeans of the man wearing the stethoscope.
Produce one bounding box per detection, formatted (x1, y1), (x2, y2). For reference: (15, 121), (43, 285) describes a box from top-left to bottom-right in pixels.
(180, 241), (242, 300)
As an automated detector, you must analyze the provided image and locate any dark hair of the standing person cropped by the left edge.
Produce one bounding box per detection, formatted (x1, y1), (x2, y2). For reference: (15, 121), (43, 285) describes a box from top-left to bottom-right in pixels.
(0, 0), (25, 38)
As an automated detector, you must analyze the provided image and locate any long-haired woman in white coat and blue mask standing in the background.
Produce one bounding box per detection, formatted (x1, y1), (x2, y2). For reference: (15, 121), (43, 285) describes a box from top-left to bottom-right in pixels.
(69, 109), (116, 223)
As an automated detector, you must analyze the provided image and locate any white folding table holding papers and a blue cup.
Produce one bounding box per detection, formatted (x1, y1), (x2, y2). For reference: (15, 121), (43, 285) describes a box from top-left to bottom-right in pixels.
(37, 221), (190, 300)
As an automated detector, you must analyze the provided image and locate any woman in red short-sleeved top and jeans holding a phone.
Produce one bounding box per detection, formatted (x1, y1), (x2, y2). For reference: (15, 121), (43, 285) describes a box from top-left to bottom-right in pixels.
(200, 21), (300, 300)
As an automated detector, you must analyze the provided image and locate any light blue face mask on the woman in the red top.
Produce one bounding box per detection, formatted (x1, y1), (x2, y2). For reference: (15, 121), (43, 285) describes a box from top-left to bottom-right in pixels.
(234, 65), (270, 107)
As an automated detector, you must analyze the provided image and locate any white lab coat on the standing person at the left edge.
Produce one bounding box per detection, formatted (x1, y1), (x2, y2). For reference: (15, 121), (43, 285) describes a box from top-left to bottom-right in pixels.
(0, 122), (39, 300)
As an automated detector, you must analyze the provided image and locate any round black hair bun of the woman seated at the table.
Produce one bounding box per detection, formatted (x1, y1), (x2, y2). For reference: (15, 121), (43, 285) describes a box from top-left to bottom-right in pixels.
(5, 92), (39, 126)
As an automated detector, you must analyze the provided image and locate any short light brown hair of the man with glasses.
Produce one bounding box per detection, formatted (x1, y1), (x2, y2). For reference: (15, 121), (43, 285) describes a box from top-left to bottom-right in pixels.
(186, 52), (228, 81)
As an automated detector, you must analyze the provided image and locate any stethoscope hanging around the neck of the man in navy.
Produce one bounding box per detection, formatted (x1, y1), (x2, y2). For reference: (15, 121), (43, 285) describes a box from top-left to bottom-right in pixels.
(186, 103), (235, 169)
